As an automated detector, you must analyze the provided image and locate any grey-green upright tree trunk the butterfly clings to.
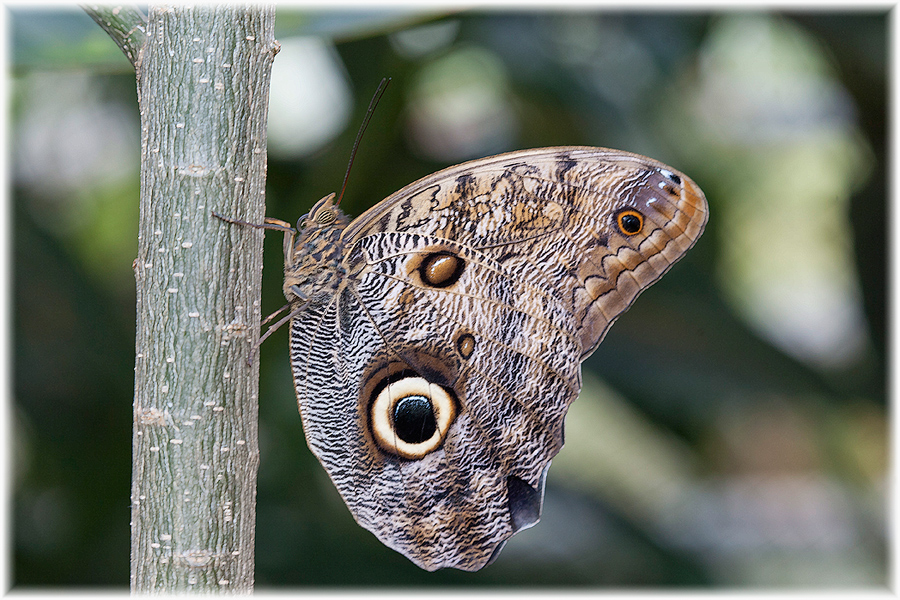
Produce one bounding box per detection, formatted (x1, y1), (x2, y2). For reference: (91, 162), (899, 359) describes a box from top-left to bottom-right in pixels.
(88, 5), (277, 593)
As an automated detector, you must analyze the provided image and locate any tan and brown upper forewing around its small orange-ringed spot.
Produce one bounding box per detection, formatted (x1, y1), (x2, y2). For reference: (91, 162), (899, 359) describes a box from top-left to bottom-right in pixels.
(342, 146), (707, 357)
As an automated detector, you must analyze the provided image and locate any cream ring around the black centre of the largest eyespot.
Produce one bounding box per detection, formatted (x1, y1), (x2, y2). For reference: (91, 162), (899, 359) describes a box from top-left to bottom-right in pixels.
(370, 377), (456, 459)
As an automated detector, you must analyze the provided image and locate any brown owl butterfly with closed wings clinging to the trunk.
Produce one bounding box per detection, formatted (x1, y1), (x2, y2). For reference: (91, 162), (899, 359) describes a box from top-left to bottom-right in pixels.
(256, 147), (707, 571)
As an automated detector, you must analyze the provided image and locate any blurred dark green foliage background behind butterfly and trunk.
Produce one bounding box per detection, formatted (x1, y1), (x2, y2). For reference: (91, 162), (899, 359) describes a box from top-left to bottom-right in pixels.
(6, 6), (889, 590)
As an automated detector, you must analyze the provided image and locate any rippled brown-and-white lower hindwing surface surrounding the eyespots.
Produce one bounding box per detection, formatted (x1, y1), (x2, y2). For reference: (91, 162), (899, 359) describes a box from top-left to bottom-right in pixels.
(292, 232), (580, 570)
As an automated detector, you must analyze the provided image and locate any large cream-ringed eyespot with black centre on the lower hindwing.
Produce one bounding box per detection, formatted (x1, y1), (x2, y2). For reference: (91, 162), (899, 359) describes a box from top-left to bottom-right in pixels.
(370, 377), (456, 459)
